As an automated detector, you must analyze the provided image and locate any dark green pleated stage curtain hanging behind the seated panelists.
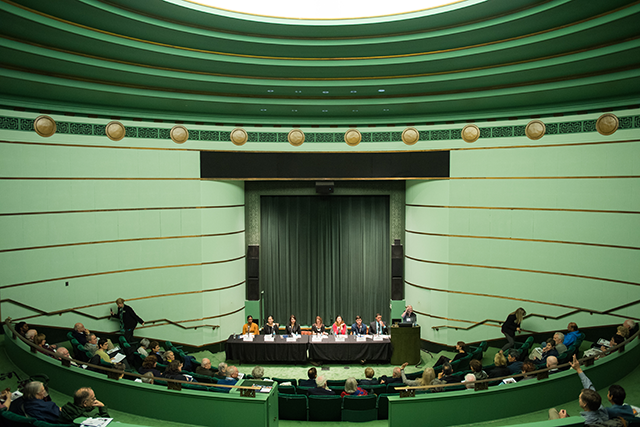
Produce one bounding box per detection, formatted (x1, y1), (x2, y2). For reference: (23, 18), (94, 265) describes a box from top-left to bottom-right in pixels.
(260, 196), (391, 326)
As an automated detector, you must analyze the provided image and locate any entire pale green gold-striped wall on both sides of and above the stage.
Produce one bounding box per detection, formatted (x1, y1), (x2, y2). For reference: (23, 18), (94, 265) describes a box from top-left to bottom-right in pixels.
(0, 109), (640, 345)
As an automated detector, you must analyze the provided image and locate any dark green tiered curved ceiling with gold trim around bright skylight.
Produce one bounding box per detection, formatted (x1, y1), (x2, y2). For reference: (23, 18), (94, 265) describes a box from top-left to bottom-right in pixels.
(0, 0), (640, 125)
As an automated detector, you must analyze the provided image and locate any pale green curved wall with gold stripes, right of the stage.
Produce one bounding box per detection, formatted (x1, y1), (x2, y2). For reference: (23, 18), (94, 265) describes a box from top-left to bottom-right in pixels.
(405, 110), (640, 345)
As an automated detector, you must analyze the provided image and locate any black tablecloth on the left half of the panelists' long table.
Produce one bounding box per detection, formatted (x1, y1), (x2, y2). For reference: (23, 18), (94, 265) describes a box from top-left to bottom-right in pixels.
(225, 335), (309, 363)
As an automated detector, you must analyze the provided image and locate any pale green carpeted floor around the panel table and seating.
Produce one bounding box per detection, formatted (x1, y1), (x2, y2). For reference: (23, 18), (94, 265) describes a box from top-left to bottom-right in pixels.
(0, 335), (640, 427)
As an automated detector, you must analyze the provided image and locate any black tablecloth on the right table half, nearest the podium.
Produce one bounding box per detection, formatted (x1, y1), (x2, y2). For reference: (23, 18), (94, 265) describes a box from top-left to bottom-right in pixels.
(309, 335), (392, 362)
